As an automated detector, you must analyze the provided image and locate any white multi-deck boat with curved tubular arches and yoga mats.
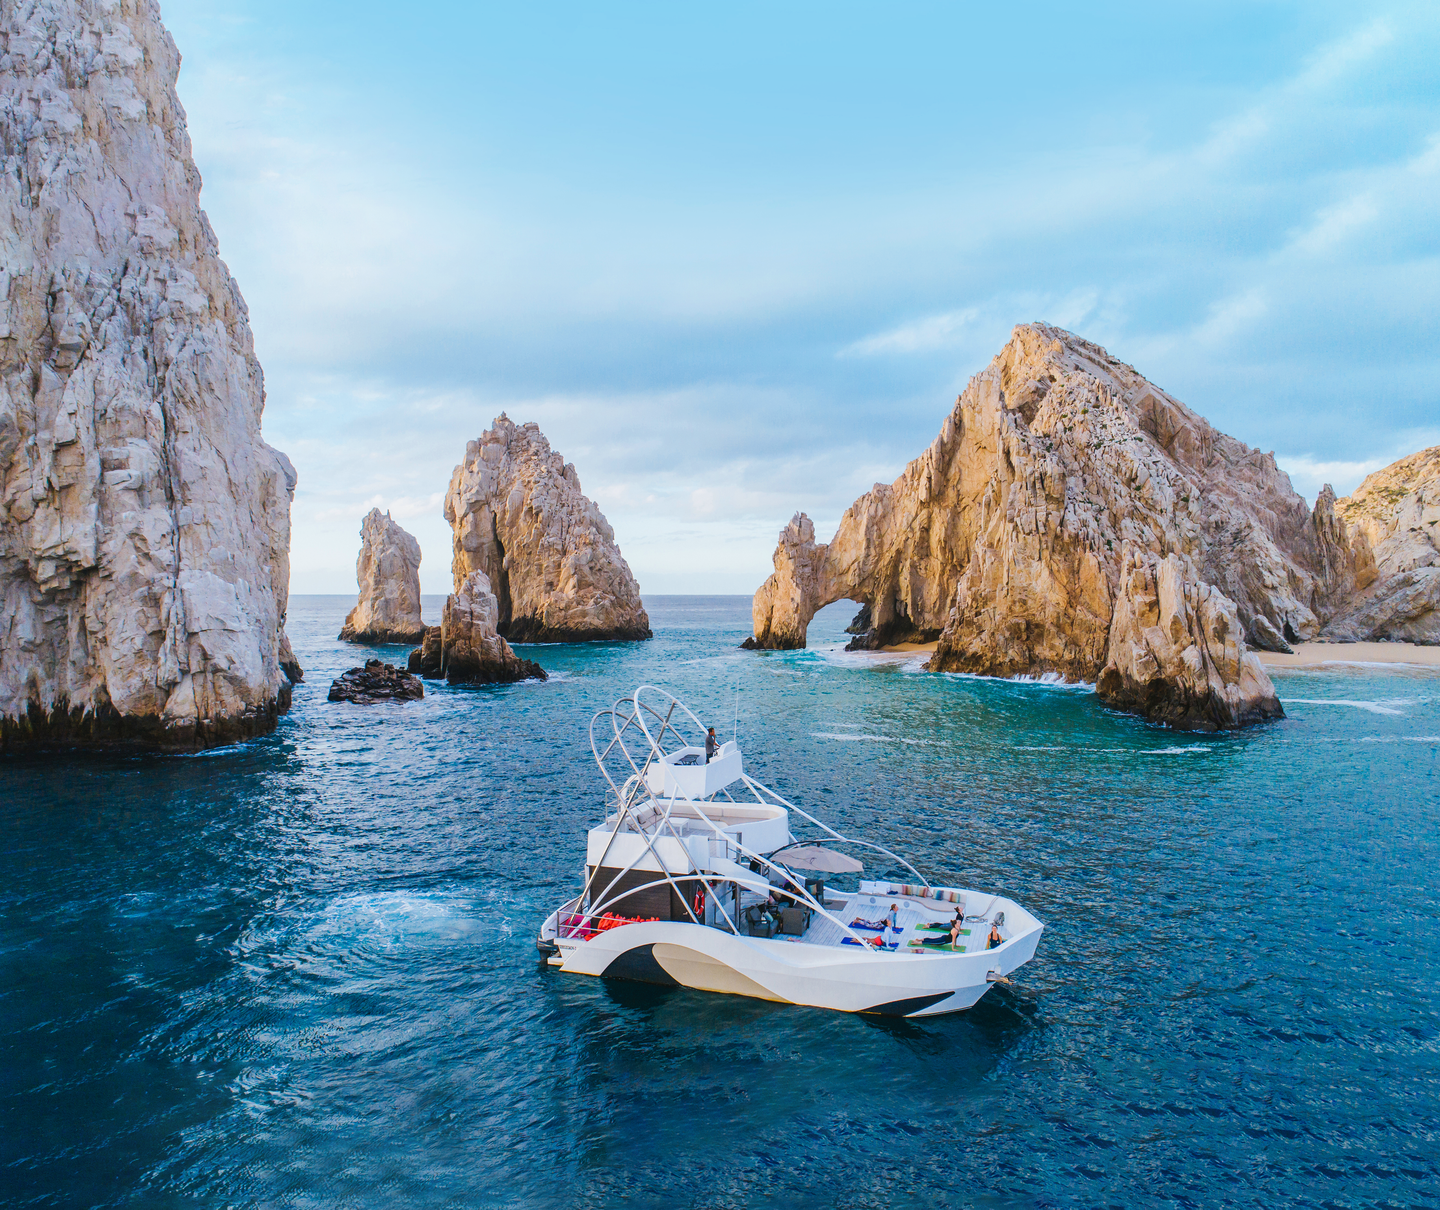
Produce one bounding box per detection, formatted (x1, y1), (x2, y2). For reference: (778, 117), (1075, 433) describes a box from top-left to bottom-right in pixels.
(536, 686), (1044, 1017)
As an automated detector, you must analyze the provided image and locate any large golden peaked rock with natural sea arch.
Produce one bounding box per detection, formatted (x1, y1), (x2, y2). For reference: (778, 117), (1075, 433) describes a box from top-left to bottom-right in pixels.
(753, 324), (1388, 727)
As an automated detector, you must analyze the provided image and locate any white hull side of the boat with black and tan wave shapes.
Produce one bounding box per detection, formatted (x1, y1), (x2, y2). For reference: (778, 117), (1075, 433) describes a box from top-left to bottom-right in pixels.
(541, 918), (1044, 1017)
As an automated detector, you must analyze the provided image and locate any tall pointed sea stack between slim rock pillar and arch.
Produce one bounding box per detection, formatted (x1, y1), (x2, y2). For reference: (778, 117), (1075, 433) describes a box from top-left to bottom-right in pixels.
(445, 413), (651, 642)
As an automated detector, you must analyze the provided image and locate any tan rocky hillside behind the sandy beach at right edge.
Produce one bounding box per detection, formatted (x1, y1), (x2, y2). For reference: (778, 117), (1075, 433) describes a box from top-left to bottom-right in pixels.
(1322, 445), (1440, 644)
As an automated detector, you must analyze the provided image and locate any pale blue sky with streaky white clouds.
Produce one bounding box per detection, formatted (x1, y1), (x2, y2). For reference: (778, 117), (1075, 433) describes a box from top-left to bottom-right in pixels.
(163, 0), (1440, 593)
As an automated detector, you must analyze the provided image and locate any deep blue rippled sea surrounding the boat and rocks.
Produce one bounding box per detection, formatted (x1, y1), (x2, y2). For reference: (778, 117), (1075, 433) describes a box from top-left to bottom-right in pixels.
(0, 598), (1440, 1210)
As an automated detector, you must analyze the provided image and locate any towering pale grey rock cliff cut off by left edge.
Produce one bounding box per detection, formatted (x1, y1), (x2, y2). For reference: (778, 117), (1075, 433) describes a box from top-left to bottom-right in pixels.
(0, 0), (298, 749)
